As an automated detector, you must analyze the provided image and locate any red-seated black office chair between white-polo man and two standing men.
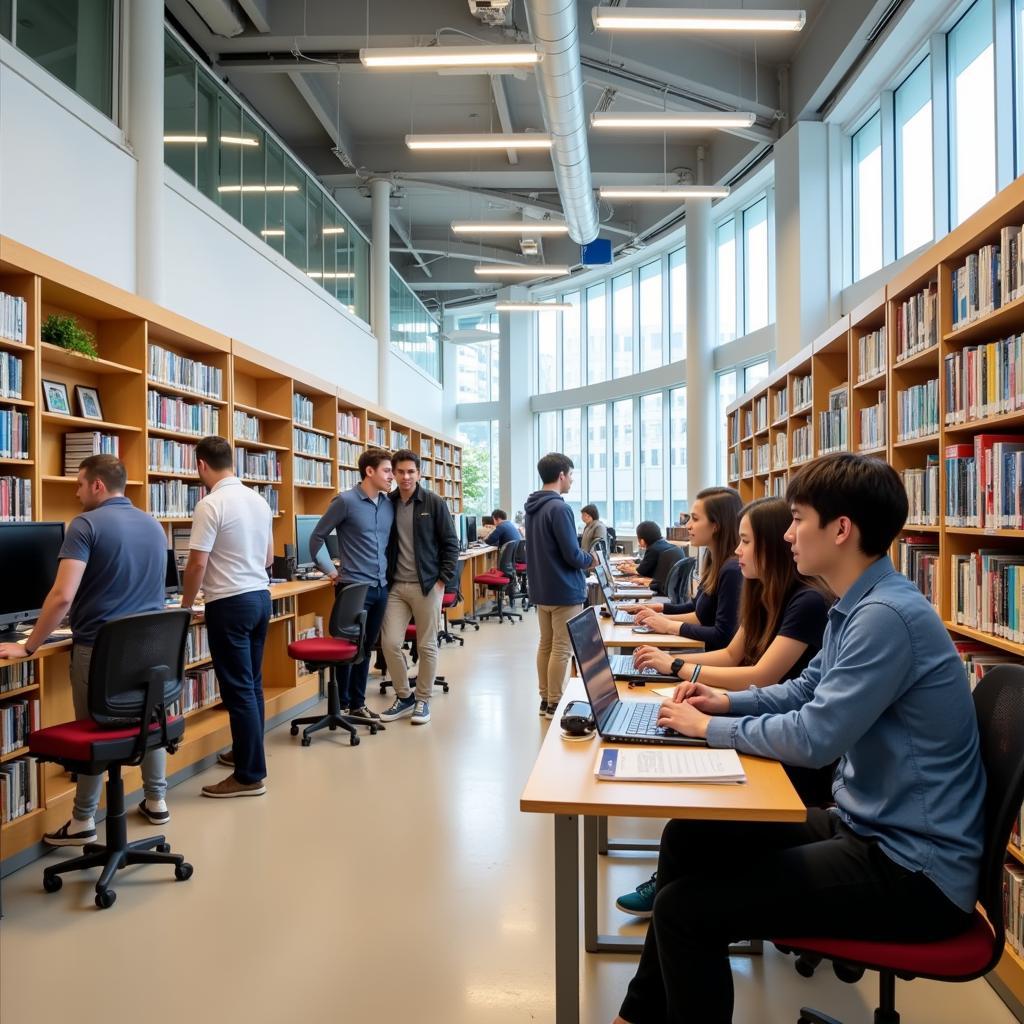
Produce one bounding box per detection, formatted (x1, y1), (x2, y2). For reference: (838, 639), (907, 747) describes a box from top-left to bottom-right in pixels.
(288, 583), (384, 746)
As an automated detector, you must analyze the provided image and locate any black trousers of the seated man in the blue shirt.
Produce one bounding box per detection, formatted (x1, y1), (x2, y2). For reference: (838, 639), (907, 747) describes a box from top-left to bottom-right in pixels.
(620, 808), (971, 1024)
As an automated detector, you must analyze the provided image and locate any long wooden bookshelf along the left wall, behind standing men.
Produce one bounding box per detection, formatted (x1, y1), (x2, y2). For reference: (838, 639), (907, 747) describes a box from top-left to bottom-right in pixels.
(0, 237), (462, 865)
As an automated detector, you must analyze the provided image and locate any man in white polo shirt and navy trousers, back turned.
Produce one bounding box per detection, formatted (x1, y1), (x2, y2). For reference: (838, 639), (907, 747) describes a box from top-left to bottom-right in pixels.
(181, 437), (273, 799)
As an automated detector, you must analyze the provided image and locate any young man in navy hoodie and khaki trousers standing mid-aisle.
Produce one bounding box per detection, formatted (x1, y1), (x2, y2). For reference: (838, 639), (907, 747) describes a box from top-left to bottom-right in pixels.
(525, 452), (597, 718)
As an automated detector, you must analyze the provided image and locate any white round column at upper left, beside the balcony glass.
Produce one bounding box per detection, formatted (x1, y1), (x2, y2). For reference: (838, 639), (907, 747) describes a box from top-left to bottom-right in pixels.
(127, 3), (164, 302)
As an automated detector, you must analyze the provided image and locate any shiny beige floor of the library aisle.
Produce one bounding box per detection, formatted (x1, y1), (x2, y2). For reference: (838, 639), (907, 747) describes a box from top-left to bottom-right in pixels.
(0, 615), (1013, 1024)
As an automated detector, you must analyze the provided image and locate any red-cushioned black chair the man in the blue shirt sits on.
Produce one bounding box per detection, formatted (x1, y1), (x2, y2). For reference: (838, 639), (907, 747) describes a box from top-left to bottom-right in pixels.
(772, 665), (1024, 1024)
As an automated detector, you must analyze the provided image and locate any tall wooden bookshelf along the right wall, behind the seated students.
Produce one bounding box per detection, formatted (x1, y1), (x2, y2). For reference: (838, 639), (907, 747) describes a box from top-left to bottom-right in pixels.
(726, 177), (1024, 1011)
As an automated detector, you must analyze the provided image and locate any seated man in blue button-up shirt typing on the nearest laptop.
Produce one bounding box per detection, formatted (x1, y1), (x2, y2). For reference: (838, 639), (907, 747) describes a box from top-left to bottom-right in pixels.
(615, 453), (985, 1024)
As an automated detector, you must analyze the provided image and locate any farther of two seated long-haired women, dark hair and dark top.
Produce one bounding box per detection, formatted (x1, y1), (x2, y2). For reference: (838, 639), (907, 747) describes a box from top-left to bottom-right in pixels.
(625, 487), (743, 650)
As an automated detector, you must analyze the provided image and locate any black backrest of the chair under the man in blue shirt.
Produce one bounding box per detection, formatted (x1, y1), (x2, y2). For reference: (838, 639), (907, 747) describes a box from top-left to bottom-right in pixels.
(974, 665), (1024, 950)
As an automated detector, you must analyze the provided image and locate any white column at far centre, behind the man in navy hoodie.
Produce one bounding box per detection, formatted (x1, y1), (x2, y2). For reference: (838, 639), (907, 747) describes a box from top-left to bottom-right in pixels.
(498, 288), (540, 514)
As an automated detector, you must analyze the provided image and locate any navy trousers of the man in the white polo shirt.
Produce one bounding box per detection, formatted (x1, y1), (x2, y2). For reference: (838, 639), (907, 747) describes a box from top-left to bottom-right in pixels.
(205, 590), (270, 783)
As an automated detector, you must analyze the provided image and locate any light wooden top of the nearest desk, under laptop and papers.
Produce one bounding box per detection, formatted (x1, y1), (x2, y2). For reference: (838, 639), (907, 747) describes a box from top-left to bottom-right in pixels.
(519, 679), (807, 821)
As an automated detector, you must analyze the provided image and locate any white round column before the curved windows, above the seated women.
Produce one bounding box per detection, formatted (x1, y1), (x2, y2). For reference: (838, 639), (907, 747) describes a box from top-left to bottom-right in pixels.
(686, 199), (718, 499)
